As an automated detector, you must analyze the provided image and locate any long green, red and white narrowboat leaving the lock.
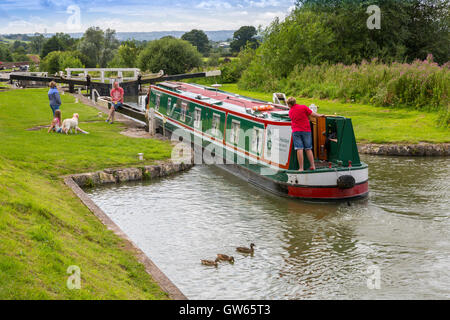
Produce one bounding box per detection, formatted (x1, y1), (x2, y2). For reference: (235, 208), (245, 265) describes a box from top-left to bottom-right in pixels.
(149, 82), (369, 200)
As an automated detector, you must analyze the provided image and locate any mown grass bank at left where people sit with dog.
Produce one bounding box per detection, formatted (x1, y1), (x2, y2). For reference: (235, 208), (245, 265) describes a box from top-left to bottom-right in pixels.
(0, 89), (171, 299)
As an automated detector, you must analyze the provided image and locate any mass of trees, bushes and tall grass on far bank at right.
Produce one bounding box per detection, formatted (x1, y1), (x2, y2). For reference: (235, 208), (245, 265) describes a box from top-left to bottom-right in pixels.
(239, 0), (450, 123)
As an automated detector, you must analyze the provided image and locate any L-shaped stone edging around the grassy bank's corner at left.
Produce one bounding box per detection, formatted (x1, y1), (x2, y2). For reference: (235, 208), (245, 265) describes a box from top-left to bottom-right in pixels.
(64, 162), (193, 300)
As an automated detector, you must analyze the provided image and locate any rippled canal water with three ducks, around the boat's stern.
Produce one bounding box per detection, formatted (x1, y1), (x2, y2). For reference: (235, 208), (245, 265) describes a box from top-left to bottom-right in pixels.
(87, 156), (450, 299)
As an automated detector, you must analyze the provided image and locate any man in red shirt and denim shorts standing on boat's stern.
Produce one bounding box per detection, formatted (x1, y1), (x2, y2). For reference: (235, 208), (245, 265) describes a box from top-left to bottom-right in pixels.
(287, 97), (324, 171)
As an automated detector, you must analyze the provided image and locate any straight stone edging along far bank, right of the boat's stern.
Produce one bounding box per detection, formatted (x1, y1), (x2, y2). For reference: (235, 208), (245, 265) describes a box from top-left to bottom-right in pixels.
(358, 143), (450, 157)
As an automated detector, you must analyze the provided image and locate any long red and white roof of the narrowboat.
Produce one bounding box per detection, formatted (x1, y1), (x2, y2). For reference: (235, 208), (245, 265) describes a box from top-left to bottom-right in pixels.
(153, 81), (290, 122)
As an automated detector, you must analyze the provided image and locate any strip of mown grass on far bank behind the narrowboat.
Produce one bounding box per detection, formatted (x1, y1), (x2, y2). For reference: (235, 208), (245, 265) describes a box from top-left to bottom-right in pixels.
(220, 84), (450, 143)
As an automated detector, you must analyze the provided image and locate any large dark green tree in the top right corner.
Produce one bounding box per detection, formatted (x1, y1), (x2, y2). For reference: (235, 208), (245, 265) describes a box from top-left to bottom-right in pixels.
(297, 0), (450, 64)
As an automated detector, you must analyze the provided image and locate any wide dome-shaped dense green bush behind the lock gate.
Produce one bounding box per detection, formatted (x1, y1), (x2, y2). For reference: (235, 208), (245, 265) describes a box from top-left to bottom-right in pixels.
(138, 37), (202, 74)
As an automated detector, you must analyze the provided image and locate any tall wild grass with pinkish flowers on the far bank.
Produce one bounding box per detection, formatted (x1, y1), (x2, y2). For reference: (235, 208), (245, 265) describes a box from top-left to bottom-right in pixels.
(239, 55), (450, 126)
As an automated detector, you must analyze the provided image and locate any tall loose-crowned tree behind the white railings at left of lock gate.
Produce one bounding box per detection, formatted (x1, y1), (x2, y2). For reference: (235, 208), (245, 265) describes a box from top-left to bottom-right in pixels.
(78, 27), (119, 68)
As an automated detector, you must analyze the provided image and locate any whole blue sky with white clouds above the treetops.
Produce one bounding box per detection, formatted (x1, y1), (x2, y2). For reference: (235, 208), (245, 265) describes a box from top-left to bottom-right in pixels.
(0, 0), (294, 34)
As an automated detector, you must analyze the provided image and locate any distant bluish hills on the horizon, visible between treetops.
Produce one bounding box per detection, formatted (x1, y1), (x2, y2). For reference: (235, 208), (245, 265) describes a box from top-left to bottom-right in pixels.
(0, 30), (235, 41)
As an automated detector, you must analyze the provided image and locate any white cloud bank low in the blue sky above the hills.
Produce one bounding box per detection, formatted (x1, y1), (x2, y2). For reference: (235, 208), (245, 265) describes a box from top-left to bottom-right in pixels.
(0, 0), (293, 33)
